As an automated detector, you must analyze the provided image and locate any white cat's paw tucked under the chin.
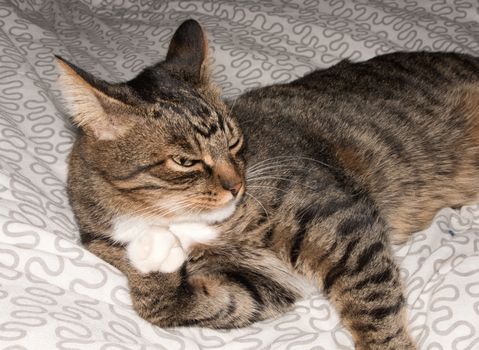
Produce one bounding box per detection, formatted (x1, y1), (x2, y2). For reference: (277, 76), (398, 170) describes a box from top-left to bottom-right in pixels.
(127, 227), (186, 273)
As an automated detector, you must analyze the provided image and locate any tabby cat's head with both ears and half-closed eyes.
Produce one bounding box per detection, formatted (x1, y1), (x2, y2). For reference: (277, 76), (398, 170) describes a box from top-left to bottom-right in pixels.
(57, 20), (245, 222)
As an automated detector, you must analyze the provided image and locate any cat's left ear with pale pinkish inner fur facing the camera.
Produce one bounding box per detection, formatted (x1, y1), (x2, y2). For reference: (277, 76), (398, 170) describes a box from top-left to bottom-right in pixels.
(55, 56), (130, 140)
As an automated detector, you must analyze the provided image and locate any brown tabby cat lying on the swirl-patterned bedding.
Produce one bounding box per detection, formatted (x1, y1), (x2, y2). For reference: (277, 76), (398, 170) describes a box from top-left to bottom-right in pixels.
(59, 20), (479, 350)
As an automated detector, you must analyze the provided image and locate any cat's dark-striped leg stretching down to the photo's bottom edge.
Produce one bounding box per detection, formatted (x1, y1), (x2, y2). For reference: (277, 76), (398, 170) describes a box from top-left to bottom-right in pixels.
(290, 198), (416, 350)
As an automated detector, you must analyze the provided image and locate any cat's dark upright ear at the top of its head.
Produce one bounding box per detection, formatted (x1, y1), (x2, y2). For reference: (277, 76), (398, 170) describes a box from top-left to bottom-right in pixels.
(165, 19), (208, 83)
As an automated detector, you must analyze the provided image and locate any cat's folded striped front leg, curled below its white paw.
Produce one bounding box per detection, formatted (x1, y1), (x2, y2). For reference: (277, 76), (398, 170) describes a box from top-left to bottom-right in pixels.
(86, 238), (300, 328)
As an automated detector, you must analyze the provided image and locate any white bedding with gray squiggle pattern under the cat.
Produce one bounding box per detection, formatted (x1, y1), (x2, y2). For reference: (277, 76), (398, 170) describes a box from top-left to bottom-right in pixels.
(0, 0), (479, 350)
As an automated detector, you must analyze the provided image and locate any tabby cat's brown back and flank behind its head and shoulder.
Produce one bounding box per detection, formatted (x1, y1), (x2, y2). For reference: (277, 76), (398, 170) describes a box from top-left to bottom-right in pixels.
(234, 52), (479, 242)
